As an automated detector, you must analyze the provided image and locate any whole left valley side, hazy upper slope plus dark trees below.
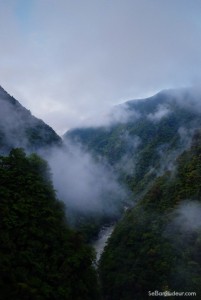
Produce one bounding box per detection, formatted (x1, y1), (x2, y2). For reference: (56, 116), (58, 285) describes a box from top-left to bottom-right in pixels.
(0, 87), (99, 300)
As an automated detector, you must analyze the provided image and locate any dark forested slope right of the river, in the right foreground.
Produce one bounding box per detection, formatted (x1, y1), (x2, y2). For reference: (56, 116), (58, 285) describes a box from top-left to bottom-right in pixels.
(99, 132), (201, 300)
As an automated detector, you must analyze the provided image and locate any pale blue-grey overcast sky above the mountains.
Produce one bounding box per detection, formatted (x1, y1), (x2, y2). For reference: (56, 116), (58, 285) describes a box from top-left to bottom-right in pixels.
(0, 0), (201, 134)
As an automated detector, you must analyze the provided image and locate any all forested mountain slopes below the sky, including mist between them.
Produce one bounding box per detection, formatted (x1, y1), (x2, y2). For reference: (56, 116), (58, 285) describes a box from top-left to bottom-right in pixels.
(0, 87), (201, 300)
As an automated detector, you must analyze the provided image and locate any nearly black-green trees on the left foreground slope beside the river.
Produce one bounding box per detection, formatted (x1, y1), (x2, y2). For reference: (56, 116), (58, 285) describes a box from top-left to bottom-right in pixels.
(0, 149), (98, 300)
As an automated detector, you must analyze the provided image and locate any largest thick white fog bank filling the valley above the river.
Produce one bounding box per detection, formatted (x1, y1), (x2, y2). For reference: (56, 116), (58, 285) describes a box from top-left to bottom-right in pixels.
(48, 142), (127, 216)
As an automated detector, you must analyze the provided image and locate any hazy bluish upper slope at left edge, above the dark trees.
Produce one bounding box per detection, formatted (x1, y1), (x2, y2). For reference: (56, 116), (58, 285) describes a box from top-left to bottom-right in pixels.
(0, 87), (61, 153)
